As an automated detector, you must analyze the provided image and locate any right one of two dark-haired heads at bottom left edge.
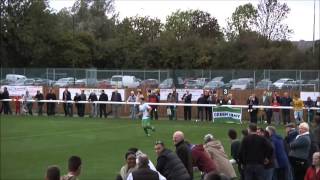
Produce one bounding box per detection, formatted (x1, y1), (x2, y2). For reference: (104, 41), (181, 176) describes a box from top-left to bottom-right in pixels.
(61, 156), (82, 180)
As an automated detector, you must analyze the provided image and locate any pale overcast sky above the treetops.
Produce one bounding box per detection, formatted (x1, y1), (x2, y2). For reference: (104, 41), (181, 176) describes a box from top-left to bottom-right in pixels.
(50, 0), (320, 41)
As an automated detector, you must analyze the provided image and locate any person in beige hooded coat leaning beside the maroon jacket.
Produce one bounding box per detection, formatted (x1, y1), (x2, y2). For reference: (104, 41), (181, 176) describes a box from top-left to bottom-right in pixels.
(203, 134), (237, 178)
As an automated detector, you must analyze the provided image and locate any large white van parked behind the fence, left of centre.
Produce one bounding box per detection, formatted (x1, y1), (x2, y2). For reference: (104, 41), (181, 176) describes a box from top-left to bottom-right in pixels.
(110, 75), (140, 88)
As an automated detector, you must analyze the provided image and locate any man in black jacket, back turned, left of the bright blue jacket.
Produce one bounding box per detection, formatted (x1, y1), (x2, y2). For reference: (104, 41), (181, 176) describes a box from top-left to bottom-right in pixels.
(239, 123), (273, 180)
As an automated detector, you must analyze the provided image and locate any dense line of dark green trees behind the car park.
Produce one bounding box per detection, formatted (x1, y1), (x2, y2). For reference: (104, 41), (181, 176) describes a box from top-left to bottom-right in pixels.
(0, 0), (320, 69)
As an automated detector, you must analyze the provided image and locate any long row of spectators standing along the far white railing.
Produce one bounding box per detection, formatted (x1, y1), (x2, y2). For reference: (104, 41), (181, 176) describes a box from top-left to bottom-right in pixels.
(0, 87), (320, 125)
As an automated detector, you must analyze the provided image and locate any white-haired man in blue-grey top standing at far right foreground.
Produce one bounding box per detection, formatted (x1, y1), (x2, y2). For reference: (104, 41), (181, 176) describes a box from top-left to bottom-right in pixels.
(289, 122), (311, 179)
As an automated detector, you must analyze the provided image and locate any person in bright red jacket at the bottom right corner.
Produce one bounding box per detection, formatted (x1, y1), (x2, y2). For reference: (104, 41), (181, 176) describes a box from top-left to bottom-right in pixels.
(304, 152), (320, 180)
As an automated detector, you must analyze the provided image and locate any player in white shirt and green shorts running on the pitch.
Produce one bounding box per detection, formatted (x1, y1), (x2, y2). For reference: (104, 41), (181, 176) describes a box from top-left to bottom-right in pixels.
(138, 97), (155, 136)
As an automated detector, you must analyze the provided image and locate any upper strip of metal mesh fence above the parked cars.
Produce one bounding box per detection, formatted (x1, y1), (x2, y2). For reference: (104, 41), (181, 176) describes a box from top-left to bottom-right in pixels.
(0, 68), (320, 91)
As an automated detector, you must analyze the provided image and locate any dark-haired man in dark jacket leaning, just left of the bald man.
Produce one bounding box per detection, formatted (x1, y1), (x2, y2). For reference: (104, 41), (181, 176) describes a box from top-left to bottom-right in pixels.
(154, 141), (191, 180)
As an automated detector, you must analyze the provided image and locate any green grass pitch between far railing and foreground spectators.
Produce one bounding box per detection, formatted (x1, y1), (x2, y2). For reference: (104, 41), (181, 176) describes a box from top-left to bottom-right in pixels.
(0, 116), (282, 180)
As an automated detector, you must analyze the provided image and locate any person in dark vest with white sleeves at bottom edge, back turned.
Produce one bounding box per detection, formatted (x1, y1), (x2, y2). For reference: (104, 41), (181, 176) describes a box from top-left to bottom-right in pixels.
(127, 154), (166, 180)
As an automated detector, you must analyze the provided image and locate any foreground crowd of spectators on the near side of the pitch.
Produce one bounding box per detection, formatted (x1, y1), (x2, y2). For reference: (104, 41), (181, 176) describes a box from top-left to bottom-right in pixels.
(46, 116), (320, 180)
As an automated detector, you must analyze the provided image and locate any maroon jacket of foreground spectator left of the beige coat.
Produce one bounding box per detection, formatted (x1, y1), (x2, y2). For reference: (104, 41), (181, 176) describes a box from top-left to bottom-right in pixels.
(191, 144), (216, 174)
